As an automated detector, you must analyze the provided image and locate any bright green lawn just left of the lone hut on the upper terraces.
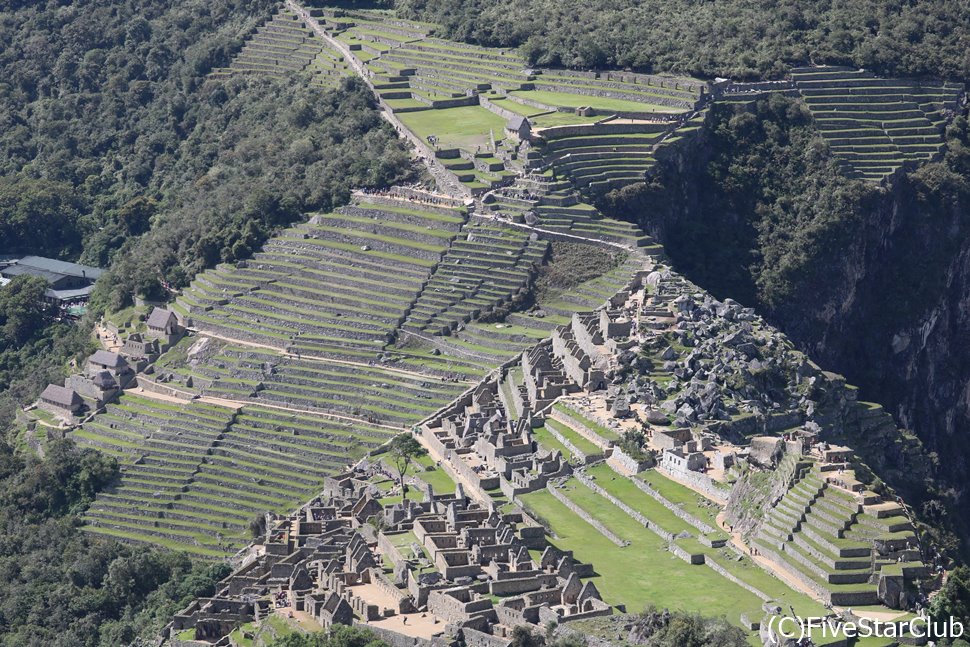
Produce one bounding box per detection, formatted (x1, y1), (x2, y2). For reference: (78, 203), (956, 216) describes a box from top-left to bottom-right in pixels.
(398, 106), (505, 151)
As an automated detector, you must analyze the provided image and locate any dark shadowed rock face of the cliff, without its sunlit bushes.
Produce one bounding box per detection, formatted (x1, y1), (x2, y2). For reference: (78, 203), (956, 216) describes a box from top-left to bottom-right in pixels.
(607, 104), (970, 541)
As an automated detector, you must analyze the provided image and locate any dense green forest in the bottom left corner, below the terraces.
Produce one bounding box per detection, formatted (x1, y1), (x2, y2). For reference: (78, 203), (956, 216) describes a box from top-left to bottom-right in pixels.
(0, 441), (228, 647)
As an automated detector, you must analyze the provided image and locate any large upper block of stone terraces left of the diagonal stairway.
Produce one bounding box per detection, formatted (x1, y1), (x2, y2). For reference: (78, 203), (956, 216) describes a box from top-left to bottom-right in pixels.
(176, 202), (464, 361)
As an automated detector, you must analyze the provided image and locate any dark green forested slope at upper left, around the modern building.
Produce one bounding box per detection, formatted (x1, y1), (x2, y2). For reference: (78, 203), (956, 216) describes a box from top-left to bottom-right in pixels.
(0, 0), (409, 430)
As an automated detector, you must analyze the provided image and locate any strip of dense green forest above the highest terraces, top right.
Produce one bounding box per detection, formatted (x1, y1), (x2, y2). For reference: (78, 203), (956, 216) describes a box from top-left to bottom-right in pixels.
(394, 0), (970, 79)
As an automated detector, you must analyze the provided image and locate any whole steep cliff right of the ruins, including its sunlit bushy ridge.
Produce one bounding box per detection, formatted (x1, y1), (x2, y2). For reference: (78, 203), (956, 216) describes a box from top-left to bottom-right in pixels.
(602, 96), (970, 556)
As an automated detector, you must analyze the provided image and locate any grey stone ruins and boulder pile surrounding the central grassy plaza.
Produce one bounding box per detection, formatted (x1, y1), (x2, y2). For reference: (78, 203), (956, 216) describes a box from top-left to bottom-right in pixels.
(169, 265), (930, 647)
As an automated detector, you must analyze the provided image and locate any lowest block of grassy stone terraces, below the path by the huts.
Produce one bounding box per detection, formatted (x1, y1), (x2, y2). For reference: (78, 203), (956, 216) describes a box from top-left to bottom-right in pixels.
(71, 394), (392, 557)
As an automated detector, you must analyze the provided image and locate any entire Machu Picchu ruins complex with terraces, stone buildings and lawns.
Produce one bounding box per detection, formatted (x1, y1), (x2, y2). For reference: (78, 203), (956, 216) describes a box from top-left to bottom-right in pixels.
(7, 0), (967, 647)
